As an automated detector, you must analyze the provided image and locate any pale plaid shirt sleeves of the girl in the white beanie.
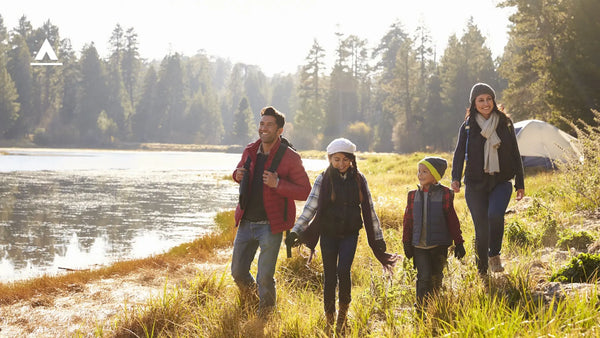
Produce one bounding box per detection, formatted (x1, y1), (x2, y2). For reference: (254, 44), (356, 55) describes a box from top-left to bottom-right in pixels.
(292, 167), (398, 267)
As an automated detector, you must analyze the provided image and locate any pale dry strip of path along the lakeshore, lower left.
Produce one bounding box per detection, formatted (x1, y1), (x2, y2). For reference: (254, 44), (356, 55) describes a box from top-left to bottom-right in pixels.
(0, 253), (230, 338)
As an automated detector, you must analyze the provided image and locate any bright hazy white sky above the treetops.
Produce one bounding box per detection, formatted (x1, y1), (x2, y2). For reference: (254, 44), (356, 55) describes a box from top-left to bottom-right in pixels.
(0, 0), (513, 76)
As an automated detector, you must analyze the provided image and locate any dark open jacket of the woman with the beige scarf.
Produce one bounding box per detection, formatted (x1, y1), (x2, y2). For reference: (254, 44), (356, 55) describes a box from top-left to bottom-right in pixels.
(452, 112), (525, 190)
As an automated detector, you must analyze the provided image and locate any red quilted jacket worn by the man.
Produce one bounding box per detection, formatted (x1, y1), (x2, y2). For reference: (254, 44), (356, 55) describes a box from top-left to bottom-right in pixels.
(233, 139), (311, 234)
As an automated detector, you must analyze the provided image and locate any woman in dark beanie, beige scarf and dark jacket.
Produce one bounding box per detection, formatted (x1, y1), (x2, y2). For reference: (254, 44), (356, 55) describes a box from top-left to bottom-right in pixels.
(451, 83), (525, 275)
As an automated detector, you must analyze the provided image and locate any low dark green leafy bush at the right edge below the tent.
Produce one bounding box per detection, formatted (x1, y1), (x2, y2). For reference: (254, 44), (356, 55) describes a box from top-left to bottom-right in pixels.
(550, 253), (600, 283)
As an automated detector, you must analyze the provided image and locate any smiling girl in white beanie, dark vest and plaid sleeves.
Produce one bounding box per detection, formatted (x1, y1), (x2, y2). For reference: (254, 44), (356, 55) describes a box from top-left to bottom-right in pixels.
(286, 138), (398, 335)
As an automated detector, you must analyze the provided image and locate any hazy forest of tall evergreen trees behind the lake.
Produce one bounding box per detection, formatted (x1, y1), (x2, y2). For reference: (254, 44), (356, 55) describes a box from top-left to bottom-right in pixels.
(0, 0), (600, 153)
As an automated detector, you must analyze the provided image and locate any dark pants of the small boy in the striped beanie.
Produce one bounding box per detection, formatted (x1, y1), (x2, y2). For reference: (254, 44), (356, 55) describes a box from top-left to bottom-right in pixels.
(413, 245), (448, 305)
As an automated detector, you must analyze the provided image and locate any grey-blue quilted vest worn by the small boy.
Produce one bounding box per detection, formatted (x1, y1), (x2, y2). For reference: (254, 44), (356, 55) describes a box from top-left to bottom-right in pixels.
(412, 184), (452, 246)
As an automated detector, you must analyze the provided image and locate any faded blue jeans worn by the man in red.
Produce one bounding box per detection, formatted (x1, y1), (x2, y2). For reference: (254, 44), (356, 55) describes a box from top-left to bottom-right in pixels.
(231, 220), (283, 309)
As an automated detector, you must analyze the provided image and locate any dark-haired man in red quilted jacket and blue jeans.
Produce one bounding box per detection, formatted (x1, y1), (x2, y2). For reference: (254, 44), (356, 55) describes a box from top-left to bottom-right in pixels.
(231, 107), (311, 317)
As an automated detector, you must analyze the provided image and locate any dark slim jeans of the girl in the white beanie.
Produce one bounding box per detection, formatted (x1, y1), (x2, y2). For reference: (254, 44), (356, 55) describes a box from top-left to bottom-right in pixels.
(320, 234), (358, 313)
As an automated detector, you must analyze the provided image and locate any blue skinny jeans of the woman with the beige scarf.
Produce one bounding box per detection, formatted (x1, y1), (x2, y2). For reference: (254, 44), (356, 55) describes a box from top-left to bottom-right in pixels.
(465, 181), (512, 273)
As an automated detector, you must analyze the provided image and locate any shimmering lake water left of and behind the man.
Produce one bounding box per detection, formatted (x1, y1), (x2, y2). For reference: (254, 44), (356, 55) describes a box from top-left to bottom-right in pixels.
(0, 149), (327, 282)
